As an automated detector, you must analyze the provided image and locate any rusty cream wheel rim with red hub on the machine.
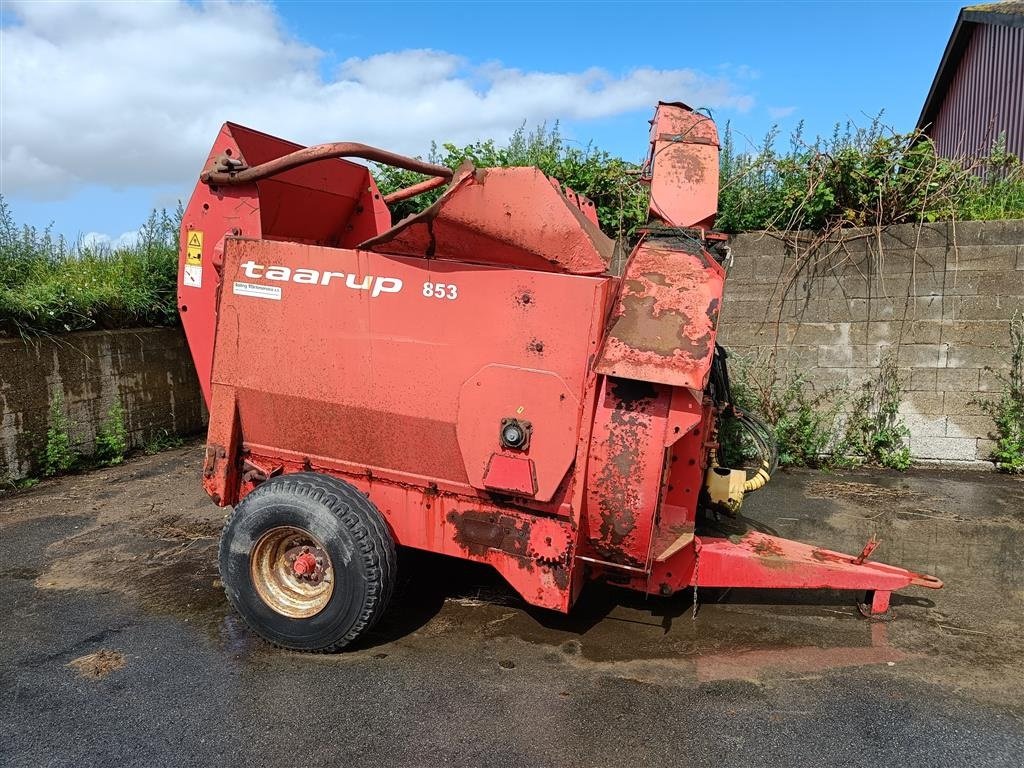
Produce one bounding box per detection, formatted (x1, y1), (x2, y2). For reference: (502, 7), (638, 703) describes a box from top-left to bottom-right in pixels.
(249, 525), (335, 618)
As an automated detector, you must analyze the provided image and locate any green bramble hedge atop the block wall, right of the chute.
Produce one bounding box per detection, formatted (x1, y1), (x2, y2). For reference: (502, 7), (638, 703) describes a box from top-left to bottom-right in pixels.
(716, 116), (1024, 232)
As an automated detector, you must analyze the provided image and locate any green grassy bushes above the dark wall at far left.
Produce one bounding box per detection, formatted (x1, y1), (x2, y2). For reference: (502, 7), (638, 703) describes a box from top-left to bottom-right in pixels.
(0, 198), (180, 335)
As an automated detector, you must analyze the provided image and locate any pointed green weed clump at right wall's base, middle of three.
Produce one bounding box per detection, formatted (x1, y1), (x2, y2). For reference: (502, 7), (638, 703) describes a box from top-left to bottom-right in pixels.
(836, 356), (910, 470)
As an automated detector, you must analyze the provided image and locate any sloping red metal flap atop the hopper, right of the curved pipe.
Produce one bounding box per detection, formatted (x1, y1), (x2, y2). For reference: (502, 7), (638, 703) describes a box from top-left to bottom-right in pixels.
(360, 165), (614, 274)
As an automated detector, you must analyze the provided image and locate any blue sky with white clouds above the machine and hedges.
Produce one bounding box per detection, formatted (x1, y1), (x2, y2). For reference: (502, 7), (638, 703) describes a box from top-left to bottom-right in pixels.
(0, 0), (961, 241)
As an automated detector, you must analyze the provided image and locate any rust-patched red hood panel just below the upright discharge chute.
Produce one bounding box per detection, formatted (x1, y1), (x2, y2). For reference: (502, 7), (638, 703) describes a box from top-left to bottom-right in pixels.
(595, 239), (725, 389)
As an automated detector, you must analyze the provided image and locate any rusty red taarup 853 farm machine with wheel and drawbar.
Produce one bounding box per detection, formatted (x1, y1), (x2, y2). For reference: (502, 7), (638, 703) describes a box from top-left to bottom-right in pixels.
(178, 103), (941, 650)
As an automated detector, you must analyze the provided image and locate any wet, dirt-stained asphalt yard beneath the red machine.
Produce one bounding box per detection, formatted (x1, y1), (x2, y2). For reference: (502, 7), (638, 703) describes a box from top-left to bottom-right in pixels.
(0, 445), (1024, 768)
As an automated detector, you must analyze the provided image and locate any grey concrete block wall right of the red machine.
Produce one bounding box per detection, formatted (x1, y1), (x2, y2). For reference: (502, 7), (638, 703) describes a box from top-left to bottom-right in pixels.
(720, 220), (1024, 463)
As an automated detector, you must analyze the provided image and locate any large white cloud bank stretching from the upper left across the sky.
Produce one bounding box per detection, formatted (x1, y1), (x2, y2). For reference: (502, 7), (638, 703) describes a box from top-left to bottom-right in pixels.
(0, 2), (754, 200)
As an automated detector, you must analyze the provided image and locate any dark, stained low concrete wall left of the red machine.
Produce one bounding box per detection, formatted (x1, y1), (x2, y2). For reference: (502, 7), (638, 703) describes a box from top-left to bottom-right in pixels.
(0, 328), (206, 480)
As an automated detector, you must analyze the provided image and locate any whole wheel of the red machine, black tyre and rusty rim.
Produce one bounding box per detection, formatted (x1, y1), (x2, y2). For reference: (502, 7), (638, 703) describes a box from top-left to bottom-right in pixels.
(220, 472), (396, 651)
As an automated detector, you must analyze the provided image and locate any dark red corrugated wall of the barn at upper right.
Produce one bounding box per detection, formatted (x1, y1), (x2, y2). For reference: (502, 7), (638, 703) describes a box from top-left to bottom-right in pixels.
(929, 24), (1024, 158)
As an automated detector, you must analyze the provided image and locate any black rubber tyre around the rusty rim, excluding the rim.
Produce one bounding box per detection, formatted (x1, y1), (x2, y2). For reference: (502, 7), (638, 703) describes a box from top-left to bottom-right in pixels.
(219, 472), (396, 651)
